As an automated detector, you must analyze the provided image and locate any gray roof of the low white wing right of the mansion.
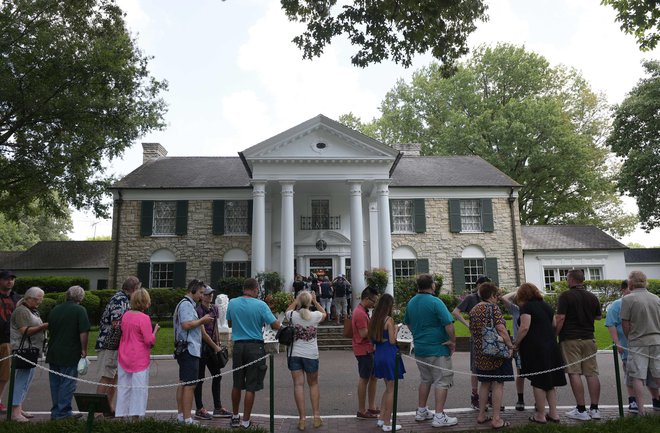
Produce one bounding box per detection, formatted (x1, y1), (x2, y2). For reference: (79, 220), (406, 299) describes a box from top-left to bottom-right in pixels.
(521, 225), (628, 251)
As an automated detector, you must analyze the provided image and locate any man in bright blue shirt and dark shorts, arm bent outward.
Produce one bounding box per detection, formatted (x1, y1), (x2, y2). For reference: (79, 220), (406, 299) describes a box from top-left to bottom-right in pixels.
(227, 278), (280, 428)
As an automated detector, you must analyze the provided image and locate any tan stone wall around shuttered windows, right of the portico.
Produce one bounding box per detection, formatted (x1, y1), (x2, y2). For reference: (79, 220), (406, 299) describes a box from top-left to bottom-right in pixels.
(392, 198), (525, 291)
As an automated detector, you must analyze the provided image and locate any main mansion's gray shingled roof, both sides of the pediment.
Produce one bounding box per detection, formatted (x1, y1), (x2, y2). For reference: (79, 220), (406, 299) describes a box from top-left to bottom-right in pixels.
(114, 156), (520, 189)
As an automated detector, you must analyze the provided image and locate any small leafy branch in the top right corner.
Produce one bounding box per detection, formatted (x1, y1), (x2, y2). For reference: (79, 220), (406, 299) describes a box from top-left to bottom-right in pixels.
(601, 0), (660, 51)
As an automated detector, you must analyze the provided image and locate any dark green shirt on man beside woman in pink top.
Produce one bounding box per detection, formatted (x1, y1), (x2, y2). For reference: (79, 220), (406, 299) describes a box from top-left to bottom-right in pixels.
(46, 301), (89, 367)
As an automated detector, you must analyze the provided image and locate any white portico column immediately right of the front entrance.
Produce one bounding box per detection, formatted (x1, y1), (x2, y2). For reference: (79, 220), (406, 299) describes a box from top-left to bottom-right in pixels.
(349, 182), (365, 298)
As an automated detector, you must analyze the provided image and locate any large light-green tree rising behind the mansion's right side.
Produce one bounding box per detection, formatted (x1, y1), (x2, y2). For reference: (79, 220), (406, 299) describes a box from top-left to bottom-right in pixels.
(342, 44), (636, 235)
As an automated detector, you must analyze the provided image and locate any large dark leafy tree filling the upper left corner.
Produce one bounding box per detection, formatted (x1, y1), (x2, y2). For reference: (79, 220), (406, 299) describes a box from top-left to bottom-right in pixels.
(0, 0), (166, 220)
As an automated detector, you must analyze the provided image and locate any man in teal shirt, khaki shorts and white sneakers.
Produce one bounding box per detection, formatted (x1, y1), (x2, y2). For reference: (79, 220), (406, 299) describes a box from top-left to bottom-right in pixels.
(404, 274), (458, 427)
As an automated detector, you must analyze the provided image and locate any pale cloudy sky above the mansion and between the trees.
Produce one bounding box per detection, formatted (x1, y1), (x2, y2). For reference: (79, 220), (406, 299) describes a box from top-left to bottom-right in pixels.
(69, 0), (660, 247)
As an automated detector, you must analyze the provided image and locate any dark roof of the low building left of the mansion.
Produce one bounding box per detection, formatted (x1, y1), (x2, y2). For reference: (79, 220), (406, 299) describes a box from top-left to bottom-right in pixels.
(6, 241), (112, 272)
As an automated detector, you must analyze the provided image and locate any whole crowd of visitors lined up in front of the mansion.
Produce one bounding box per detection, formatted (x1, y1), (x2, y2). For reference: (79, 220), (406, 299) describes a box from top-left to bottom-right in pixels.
(0, 270), (660, 432)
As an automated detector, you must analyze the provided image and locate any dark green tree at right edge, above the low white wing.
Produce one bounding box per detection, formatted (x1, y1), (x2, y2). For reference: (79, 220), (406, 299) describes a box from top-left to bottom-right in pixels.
(607, 61), (660, 231)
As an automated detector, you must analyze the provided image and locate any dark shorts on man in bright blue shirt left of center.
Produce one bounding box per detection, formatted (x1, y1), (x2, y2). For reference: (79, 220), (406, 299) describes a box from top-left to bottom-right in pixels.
(232, 341), (268, 392)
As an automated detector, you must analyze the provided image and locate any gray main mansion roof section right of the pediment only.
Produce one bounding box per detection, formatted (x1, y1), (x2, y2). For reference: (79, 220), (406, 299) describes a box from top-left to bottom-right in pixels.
(390, 156), (520, 187)
